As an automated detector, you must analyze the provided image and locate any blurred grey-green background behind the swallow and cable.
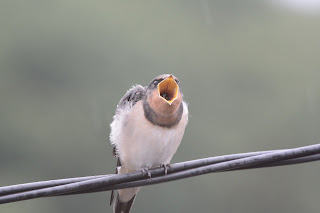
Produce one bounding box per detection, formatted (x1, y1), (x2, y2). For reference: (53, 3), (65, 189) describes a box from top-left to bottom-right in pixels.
(0, 0), (320, 213)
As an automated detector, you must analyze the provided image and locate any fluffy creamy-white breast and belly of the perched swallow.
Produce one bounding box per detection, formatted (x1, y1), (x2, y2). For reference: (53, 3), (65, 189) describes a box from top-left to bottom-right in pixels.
(110, 101), (188, 171)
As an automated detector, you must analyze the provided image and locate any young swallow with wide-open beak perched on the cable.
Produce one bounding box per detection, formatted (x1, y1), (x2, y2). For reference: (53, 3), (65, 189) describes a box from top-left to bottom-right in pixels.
(110, 74), (188, 213)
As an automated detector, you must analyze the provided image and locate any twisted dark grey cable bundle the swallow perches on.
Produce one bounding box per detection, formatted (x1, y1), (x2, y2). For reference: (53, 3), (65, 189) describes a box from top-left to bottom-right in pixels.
(0, 144), (320, 204)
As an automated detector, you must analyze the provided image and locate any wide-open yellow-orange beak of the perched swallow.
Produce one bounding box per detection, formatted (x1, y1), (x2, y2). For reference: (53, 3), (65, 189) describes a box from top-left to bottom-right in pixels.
(158, 75), (179, 105)
